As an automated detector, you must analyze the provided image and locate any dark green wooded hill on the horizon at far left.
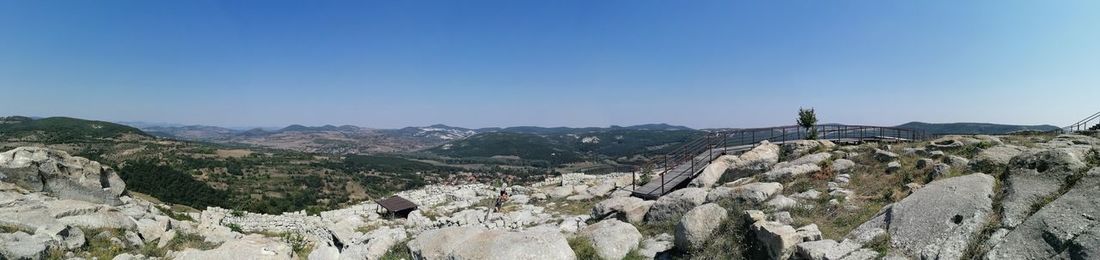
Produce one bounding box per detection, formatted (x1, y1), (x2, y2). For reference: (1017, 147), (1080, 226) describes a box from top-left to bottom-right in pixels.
(0, 117), (151, 143)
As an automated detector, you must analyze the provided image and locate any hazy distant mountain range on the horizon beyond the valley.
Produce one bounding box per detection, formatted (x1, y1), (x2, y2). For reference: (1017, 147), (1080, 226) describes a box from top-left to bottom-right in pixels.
(124, 120), (695, 156)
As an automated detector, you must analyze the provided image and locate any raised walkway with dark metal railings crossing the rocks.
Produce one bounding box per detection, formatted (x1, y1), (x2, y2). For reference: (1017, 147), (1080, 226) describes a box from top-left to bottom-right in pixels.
(631, 124), (928, 199)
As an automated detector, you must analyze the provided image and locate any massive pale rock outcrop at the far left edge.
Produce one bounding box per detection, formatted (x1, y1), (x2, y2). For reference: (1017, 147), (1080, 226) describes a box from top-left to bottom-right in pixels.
(0, 147), (127, 205)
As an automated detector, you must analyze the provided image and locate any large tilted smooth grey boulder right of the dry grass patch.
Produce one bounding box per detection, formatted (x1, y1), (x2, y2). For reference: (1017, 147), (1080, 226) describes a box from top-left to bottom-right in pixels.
(848, 173), (994, 259)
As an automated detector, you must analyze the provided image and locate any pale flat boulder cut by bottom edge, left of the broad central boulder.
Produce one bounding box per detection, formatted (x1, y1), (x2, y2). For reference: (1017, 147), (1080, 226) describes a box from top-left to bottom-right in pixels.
(171, 235), (297, 260)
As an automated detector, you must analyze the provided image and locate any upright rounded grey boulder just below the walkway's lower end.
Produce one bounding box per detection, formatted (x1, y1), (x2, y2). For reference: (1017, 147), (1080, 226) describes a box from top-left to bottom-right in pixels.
(675, 203), (727, 250)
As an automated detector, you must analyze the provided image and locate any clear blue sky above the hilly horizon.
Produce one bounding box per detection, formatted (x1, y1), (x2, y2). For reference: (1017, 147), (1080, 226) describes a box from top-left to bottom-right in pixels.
(0, 0), (1100, 128)
